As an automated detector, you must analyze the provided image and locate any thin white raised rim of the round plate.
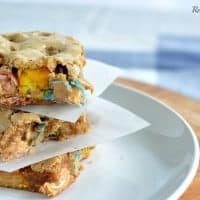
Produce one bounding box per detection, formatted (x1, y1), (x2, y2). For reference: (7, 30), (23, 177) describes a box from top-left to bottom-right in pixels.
(112, 82), (200, 200)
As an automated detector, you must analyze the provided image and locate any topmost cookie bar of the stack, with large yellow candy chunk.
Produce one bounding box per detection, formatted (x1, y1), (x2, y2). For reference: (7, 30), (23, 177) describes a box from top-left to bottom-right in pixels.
(0, 31), (93, 106)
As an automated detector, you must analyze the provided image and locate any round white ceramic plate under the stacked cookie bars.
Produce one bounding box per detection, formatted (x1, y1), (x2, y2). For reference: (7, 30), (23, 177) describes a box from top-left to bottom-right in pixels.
(0, 85), (199, 200)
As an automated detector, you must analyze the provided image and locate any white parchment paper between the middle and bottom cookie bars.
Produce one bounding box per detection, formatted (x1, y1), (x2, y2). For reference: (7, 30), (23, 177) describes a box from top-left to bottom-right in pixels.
(0, 97), (149, 172)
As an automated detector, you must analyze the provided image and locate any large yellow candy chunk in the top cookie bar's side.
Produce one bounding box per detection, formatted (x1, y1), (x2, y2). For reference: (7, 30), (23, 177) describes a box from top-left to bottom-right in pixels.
(18, 67), (49, 98)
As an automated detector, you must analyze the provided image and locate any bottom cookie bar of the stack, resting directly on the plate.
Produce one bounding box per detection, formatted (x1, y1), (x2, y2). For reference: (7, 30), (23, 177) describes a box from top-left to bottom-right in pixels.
(0, 148), (92, 196)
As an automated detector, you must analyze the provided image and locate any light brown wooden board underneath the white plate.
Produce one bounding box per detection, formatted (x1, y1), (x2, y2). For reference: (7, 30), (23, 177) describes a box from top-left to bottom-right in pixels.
(116, 78), (200, 200)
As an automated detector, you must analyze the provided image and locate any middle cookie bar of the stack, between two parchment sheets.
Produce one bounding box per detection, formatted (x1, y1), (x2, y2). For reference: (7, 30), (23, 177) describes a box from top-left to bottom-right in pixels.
(0, 108), (89, 161)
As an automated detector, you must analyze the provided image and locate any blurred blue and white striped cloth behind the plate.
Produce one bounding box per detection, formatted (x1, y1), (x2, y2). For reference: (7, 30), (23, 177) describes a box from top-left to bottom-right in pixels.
(87, 35), (200, 100)
